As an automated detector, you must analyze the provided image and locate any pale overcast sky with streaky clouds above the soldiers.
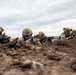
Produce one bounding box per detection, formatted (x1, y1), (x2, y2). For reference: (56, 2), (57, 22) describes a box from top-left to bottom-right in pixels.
(0, 0), (76, 37)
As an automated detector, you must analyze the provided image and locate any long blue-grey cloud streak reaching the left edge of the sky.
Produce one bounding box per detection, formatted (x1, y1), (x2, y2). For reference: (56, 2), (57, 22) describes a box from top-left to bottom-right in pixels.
(0, 15), (38, 25)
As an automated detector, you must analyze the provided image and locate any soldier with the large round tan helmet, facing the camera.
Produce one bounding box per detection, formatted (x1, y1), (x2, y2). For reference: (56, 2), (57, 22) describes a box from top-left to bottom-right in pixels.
(18, 28), (33, 45)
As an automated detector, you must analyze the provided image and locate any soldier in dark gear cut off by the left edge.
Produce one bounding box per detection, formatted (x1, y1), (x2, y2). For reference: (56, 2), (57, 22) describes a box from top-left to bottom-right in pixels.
(0, 27), (11, 44)
